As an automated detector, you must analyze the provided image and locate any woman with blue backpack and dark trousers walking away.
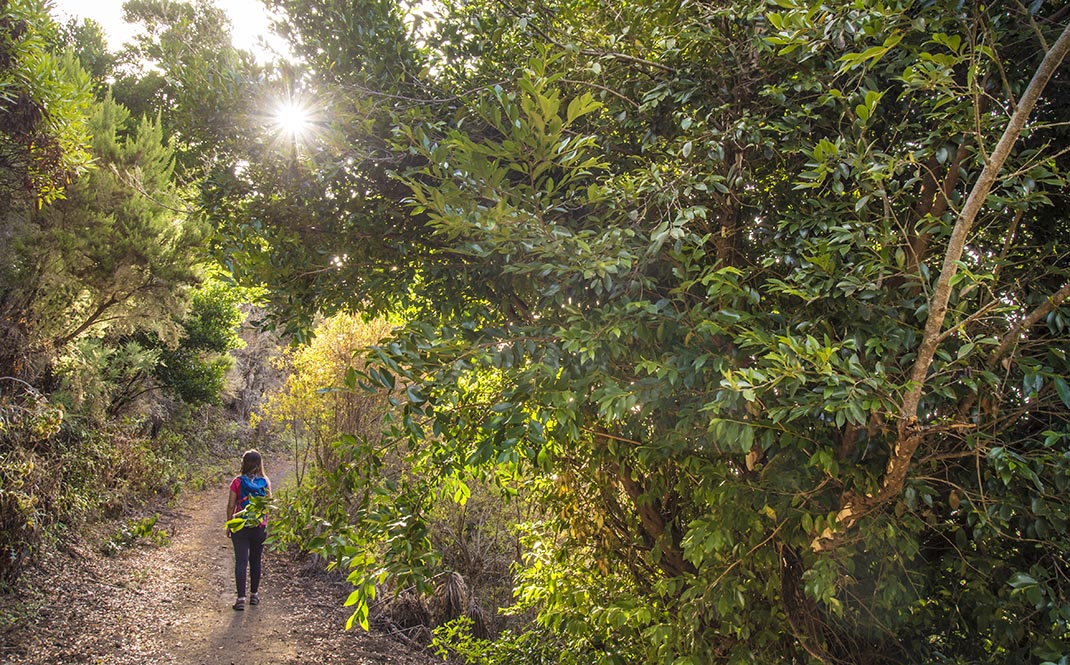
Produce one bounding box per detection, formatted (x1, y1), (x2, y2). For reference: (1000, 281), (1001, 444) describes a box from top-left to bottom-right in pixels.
(227, 450), (271, 611)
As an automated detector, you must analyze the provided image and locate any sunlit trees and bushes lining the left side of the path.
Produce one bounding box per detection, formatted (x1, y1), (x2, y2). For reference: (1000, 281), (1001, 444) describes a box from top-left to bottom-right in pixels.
(0, 0), (254, 590)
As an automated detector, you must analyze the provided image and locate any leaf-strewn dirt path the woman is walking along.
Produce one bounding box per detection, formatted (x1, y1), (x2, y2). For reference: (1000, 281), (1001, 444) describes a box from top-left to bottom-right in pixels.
(0, 458), (442, 665)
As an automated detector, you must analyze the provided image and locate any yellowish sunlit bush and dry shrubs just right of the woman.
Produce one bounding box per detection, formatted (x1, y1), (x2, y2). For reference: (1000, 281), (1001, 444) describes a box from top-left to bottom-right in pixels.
(256, 314), (526, 636)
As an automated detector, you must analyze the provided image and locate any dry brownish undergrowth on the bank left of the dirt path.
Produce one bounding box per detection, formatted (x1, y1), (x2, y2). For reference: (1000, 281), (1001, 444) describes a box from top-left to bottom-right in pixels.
(0, 383), (256, 592)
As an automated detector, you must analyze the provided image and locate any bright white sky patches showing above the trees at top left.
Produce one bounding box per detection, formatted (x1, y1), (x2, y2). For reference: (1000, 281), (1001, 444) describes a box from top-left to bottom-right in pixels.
(51, 0), (288, 60)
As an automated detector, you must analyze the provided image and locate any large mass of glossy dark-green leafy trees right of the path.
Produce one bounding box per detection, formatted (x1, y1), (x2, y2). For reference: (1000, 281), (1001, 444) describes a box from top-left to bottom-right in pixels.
(205, 0), (1070, 663)
